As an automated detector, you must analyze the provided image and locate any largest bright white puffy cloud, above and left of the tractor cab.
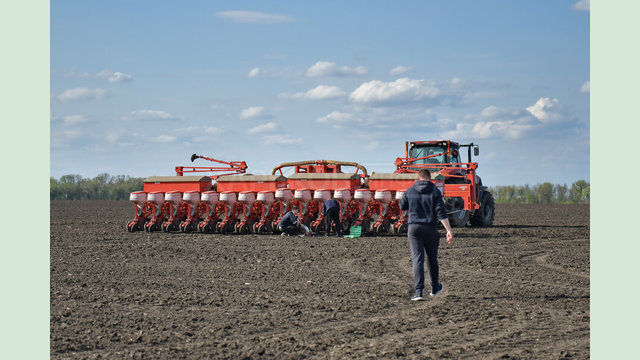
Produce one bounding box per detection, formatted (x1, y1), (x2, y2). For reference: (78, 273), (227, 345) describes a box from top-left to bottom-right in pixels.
(349, 78), (440, 103)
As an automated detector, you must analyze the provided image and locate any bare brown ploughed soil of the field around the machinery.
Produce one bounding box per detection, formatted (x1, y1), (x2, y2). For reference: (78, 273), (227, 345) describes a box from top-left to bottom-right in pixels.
(50, 201), (590, 359)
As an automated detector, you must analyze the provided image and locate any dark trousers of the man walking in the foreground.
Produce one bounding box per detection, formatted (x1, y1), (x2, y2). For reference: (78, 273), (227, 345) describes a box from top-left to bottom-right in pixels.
(407, 224), (440, 290)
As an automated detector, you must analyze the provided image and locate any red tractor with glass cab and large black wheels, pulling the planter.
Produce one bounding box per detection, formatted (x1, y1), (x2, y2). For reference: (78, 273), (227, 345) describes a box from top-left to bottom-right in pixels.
(395, 140), (495, 226)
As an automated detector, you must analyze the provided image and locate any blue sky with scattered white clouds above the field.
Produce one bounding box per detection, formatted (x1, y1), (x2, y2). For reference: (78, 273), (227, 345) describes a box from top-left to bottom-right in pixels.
(50, 0), (590, 186)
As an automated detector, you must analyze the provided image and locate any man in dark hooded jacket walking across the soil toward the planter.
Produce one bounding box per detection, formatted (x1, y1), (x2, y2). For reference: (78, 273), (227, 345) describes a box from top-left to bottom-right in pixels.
(400, 169), (453, 300)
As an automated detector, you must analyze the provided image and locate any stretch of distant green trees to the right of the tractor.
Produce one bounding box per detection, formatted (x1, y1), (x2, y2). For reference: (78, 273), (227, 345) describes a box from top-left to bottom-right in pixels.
(489, 180), (591, 204)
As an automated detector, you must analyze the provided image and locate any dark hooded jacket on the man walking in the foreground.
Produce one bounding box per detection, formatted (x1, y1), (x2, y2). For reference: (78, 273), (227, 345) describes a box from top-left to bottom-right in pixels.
(400, 180), (447, 225)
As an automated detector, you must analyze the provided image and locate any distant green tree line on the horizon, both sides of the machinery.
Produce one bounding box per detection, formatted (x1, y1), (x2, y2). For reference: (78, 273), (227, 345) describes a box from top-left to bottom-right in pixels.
(50, 173), (590, 204)
